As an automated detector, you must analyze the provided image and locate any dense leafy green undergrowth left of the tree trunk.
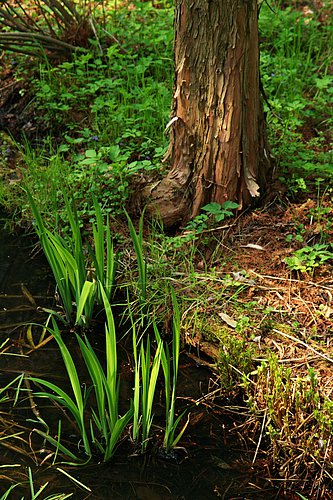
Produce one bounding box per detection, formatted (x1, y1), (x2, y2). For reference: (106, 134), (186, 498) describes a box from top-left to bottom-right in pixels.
(0, 2), (173, 223)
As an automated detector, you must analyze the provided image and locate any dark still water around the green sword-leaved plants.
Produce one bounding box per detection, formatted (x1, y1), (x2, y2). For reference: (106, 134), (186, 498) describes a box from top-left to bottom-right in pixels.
(0, 230), (284, 500)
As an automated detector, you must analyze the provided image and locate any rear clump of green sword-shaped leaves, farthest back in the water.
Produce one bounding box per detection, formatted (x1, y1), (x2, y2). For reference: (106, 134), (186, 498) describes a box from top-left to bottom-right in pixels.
(27, 191), (117, 326)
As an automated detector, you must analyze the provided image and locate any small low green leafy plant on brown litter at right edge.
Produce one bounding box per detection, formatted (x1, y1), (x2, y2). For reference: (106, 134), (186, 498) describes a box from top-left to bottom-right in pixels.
(284, 243), (333, 272)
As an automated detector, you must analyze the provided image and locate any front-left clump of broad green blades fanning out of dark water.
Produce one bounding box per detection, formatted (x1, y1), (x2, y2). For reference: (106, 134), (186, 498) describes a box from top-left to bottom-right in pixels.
(30, 283), (133, 462)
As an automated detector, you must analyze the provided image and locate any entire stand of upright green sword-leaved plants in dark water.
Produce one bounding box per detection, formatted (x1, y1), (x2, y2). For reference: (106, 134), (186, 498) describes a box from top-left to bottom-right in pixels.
(23, 193), (188, 463)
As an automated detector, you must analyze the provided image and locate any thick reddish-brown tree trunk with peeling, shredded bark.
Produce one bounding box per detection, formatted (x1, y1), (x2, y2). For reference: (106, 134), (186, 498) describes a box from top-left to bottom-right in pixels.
(149, 0), (270, 226)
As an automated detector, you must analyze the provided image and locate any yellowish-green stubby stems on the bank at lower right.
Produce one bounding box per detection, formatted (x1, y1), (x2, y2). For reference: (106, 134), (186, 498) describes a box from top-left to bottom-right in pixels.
(244, 355), (333, 477)
